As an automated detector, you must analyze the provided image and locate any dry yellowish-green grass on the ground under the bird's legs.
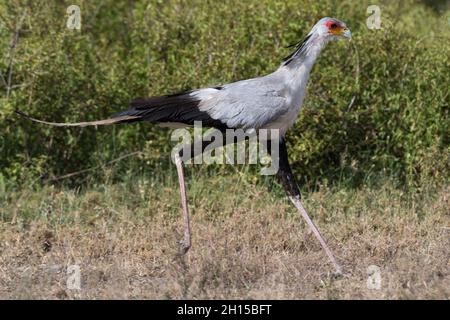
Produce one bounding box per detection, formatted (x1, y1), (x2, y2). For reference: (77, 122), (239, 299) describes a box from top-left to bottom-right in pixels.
(0, 177), (450, 299)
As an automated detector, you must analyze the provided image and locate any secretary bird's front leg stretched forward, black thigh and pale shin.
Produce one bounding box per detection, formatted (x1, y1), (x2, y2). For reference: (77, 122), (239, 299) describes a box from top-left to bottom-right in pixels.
(270, 140), (342, 274)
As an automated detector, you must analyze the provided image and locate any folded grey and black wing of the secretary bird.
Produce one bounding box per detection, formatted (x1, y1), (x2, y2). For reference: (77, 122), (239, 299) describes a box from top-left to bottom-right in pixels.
(112, 77), (288, 129)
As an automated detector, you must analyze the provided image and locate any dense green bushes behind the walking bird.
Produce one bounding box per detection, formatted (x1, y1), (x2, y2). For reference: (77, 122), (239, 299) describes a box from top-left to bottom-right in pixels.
(0, 0), (450, 188)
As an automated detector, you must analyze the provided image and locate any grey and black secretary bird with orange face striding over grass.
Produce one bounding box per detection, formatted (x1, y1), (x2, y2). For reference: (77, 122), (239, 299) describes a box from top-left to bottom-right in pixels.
(16, 17), (351, 274)
